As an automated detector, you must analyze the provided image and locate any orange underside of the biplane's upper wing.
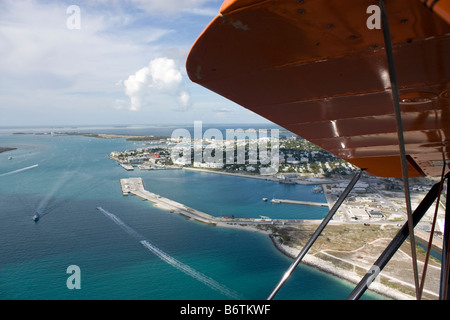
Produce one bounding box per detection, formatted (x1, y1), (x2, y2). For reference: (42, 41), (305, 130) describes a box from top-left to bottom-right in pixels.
(187, 0), (450, 177)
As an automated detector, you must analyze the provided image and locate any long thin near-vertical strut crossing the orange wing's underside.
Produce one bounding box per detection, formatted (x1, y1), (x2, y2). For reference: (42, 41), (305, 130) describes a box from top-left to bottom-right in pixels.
(379, 0), (419, 299)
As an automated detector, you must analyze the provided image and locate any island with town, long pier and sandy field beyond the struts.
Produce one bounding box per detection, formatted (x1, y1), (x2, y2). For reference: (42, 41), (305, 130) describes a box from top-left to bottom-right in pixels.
(103, 132), (445, 300)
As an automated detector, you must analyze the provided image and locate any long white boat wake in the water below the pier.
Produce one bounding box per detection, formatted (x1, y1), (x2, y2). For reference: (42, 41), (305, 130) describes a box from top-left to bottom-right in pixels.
(97, 207), (242, 300)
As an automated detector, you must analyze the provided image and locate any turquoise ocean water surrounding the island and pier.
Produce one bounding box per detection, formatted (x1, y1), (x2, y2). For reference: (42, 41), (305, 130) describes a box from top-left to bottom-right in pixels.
(0, 129), (379, 300)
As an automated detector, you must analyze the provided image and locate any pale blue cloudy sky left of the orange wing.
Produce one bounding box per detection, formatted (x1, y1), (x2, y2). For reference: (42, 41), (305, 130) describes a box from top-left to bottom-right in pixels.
(0, 0), (267, 126)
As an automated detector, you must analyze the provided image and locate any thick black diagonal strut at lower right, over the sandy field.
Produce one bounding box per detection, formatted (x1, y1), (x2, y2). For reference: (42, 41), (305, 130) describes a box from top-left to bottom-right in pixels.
(347, 173), (450, 300)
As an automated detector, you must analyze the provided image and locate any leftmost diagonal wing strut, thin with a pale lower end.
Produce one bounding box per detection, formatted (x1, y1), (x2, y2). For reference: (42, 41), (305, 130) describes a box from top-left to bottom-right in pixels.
(267, 169), (364, 300)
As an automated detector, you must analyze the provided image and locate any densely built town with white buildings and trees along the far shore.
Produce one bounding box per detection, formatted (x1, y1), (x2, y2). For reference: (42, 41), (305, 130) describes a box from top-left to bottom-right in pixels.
(110, 136), (364, 176)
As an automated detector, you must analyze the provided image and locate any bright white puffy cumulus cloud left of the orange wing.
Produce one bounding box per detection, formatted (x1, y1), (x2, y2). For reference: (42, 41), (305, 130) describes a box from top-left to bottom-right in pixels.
(123, 58), (190, 111)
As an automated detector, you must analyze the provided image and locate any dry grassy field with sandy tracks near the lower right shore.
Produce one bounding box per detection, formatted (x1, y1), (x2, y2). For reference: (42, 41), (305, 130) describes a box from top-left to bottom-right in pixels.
(272, 224), (440, 300)
